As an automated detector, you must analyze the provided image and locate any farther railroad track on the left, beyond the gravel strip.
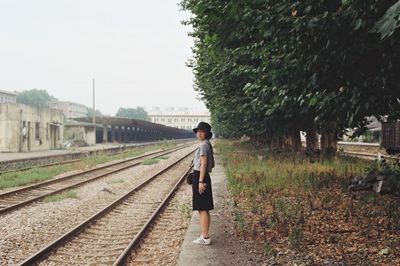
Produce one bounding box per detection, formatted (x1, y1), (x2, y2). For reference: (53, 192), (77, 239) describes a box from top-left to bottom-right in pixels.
(0, 142), (189, 215)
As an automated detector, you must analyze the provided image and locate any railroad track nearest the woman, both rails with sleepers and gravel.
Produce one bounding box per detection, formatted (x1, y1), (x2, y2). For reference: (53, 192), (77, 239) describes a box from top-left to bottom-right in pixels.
(19, 149), (195, 265)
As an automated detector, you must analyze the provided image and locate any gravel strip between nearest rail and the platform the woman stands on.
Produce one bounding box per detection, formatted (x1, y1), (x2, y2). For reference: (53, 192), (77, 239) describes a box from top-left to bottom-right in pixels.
(127, 180), (192, 266)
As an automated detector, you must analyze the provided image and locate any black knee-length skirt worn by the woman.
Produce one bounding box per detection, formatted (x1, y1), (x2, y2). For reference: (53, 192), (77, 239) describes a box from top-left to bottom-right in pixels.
(192, 170), (214, 211)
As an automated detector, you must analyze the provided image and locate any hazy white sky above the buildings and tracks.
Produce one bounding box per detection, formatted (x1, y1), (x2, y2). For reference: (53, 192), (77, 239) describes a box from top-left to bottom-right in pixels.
(0, 0), (205, 114)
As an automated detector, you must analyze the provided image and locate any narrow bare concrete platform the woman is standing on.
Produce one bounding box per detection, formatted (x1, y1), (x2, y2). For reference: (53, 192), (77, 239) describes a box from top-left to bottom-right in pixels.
(177, 154), (263, 266)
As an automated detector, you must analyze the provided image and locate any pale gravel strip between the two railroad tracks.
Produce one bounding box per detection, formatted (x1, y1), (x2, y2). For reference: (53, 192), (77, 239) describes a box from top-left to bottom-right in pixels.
(0, 146), (195, 265)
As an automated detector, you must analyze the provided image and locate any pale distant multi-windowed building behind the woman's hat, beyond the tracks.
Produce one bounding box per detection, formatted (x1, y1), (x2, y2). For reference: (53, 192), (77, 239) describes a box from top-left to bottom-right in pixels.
(148, 108), (211, 130)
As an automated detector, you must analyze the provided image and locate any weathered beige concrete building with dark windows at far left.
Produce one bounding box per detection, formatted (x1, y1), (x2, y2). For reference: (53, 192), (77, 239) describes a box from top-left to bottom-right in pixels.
(0, 103), (64, 152)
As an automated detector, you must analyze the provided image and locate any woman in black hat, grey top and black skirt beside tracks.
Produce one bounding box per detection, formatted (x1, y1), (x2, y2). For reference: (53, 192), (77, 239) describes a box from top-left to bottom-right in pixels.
(192, 122), (214, 245)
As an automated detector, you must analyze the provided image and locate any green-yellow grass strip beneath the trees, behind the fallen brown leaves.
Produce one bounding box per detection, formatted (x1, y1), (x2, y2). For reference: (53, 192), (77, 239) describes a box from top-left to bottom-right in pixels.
(217, 141), (371, 196)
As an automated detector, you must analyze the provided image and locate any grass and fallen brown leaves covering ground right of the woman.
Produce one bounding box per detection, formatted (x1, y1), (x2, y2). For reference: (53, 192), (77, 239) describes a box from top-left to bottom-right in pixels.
(216, 140), (400, 265)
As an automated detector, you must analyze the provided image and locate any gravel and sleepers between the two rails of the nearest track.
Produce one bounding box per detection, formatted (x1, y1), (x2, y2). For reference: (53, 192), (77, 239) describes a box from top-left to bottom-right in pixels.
(39, 155), (190, 265)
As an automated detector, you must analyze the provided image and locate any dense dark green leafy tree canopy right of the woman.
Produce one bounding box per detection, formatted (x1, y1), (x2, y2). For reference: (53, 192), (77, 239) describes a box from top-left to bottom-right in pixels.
(182, 0), (400, 153)
